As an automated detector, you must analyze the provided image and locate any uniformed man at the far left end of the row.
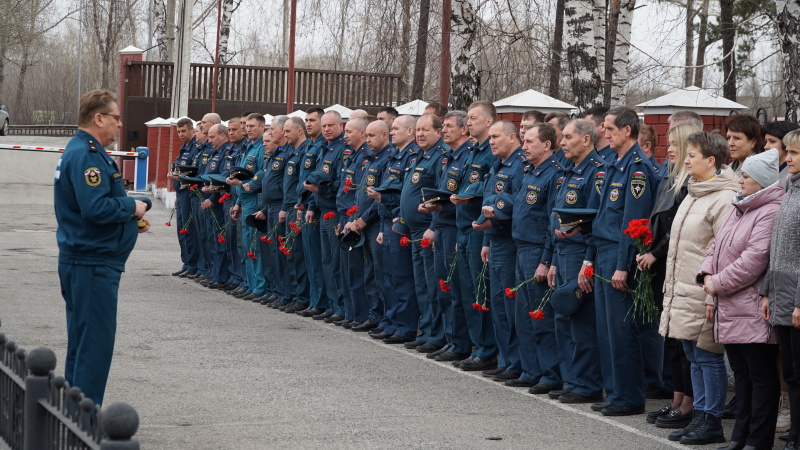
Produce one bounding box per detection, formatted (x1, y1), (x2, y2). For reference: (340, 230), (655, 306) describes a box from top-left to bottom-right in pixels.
(167, 117), (198, 278)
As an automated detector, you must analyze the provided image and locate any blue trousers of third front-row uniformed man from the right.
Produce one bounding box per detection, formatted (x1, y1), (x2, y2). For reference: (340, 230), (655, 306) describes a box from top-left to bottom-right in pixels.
(508, 242), (548, 386)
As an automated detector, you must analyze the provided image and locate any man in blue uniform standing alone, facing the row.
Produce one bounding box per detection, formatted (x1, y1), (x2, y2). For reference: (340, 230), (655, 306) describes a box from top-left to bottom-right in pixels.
(54, 91), (150, 405)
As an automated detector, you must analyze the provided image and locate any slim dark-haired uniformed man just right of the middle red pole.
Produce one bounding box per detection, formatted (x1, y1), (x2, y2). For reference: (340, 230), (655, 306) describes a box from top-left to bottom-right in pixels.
(295, 106), (327, 317)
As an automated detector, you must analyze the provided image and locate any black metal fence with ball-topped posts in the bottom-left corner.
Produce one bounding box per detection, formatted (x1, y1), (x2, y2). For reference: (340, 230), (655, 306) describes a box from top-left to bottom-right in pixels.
(0, 333), (139, 450)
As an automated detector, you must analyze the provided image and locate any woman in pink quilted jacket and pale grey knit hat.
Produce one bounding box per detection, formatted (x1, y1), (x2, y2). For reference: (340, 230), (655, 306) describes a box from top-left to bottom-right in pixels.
(697, 149), (784, 450)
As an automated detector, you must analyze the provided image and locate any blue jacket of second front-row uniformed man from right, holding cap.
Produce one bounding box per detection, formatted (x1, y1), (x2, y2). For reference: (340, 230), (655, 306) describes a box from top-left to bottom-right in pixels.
(550, 150), (606, 260)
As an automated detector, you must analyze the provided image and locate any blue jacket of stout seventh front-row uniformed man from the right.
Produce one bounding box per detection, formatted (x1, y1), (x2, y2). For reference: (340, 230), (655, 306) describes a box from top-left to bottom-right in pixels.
(400, 138), (450, 231)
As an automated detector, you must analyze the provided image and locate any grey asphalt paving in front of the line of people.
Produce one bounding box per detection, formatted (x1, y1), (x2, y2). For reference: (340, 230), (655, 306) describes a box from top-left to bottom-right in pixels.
(0, 136), (764, 449)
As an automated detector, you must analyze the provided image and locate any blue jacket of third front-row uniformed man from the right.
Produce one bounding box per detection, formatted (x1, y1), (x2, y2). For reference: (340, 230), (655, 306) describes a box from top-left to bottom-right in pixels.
(511, 156), (561, 261)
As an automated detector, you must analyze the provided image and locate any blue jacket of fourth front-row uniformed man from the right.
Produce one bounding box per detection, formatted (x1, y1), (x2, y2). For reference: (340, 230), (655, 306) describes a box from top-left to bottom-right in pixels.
(483, 147), (528, 246)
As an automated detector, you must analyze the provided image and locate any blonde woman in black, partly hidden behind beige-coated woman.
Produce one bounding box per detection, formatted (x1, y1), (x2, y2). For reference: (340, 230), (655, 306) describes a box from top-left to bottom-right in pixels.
(637, 124), (700, 428)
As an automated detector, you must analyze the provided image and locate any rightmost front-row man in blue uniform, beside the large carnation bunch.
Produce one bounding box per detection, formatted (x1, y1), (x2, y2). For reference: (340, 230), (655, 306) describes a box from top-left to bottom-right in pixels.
(581, 108), (663, 416)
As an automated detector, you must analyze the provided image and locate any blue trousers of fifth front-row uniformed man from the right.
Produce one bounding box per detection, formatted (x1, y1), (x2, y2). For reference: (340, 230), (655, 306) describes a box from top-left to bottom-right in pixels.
(456, 231), (497, 359)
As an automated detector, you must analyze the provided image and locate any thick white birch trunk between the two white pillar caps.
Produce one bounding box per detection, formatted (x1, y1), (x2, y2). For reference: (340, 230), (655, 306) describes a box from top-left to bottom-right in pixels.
(564, 0), (603, 111)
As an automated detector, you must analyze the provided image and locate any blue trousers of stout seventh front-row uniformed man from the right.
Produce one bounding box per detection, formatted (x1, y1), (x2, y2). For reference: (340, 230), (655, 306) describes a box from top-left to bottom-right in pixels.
(410, 229), (446, 346)
